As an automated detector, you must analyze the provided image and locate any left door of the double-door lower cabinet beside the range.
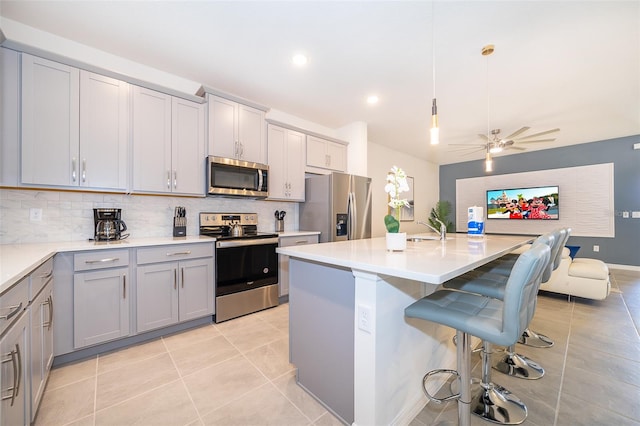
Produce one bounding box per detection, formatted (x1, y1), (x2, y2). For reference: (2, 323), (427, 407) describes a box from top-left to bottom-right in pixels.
(136, 262), (178, 333)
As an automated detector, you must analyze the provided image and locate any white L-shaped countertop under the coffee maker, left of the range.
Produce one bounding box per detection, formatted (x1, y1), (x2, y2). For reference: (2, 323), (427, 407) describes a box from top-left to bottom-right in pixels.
(0, 236), (215, 294)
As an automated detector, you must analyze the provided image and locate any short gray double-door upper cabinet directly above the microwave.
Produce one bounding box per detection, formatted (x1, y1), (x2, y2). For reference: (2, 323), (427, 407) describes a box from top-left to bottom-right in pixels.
(206, 94), (267, 164)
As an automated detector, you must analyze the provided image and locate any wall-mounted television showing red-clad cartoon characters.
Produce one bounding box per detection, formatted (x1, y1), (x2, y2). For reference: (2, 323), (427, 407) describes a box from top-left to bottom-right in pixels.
(487, 186), (559, 220)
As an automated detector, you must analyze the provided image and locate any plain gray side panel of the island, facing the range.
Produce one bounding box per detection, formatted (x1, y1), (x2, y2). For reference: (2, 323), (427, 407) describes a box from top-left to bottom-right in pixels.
(289, 258), (355, 424)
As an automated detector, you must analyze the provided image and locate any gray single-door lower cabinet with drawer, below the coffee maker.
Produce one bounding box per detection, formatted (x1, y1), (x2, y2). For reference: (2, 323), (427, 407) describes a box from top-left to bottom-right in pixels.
(73, 249), (130, 349)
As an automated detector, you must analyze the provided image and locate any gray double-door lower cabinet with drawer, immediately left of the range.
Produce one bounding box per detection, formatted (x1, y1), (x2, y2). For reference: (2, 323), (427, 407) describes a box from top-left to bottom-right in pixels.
(136, 244), (214, 333)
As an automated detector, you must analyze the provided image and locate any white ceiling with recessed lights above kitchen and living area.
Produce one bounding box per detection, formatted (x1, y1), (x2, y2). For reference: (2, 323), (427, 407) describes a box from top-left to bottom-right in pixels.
(0, 0), (640, 164)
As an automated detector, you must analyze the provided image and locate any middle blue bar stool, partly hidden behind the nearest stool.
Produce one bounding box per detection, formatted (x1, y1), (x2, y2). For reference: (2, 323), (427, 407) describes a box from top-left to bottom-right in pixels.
(443, 230), (562, 387)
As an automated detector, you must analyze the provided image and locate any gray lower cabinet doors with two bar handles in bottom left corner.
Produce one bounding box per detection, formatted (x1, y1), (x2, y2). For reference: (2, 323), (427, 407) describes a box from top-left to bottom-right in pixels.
(0, 314), (31, 425)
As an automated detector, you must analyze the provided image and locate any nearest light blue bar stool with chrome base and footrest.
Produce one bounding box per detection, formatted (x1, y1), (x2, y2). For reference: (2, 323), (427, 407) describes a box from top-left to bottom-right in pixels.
(405, 244), (550, 426)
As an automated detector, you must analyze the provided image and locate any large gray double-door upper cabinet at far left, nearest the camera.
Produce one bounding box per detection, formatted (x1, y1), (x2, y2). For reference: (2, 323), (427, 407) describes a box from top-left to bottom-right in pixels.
(21, 53), (129, 192)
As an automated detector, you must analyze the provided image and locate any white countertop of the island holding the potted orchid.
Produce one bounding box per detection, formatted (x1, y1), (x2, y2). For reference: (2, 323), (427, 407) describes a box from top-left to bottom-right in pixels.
(277, 234), (534, 284)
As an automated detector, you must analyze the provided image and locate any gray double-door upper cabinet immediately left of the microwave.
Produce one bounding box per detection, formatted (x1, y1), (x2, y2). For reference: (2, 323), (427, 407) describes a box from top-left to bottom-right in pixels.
(132, 86), (205, 196)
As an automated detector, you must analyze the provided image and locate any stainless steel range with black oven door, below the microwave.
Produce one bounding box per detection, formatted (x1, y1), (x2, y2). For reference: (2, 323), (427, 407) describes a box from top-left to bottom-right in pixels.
(200, 212), (278, 322)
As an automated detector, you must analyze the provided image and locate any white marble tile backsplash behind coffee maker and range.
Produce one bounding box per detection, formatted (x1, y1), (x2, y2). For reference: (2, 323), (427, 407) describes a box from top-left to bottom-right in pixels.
(0, 189), (298, 244)
